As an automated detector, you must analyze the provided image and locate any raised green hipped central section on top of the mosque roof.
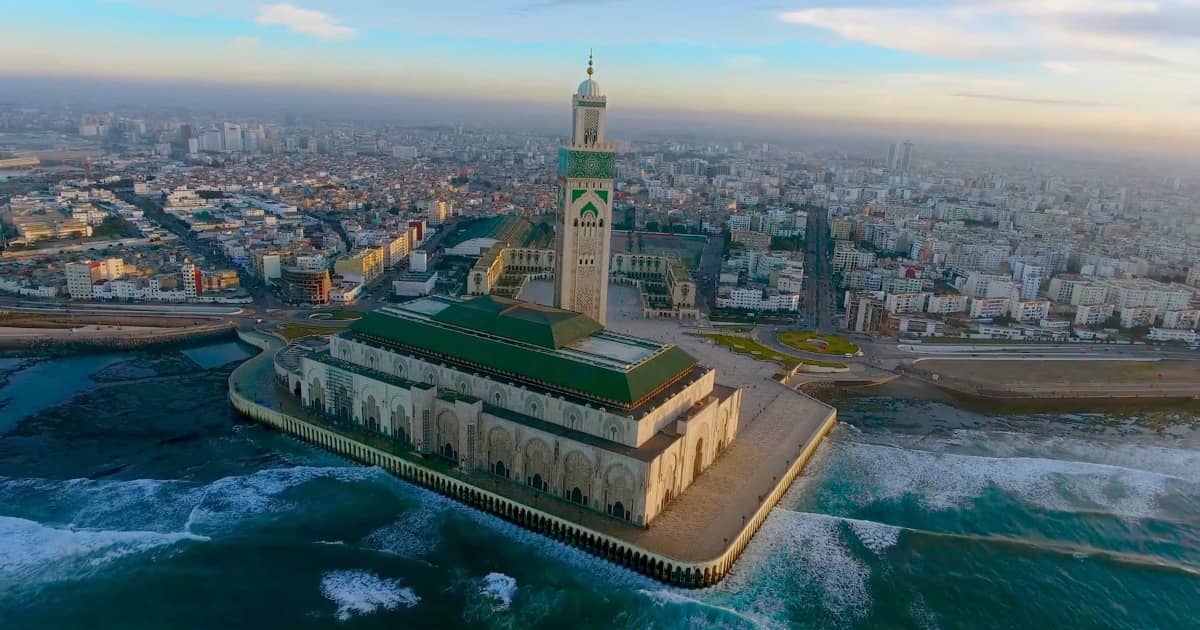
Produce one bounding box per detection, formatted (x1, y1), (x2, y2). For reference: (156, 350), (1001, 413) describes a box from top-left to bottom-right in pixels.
(432, 295), (601, 349)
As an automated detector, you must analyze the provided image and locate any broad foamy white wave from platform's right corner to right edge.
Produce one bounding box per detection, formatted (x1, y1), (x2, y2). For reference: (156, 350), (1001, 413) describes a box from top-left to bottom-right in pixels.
(811, 442), (1198, 518)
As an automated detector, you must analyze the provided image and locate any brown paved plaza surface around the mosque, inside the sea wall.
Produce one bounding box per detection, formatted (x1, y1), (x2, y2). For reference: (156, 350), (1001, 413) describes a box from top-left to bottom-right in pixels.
(232, 294), (834, 562)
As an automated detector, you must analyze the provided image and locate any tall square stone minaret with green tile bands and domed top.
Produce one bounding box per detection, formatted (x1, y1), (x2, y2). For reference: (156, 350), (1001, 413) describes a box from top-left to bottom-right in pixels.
(554, 55), (616, 325)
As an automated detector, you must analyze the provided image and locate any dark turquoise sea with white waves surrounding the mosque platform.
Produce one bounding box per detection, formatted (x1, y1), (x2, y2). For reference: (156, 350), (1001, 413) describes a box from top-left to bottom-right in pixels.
(0, 348), (1200, 629)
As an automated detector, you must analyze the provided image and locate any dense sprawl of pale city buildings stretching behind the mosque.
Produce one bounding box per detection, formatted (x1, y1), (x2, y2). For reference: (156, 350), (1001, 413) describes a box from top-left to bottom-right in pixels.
(0, 96), (1200, 342)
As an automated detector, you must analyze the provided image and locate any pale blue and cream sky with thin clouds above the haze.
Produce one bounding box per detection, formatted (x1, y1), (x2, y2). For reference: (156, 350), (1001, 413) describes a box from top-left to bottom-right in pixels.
(0, 0), (1200, 152)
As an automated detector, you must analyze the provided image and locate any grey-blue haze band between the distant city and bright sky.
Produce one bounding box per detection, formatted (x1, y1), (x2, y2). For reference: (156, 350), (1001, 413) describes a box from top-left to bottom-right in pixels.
(0, 73), (1193, 163)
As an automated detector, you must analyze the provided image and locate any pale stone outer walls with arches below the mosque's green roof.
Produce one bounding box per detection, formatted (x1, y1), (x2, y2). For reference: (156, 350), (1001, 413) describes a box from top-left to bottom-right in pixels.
(289, 337), (742, 526)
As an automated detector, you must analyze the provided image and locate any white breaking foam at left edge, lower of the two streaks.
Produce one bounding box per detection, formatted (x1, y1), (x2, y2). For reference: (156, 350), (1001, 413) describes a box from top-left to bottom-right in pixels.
(0, 516), (208, 584)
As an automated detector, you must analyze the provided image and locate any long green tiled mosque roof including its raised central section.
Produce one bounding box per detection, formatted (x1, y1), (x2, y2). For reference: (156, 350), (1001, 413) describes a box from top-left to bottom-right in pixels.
(348, 296), (696, 408)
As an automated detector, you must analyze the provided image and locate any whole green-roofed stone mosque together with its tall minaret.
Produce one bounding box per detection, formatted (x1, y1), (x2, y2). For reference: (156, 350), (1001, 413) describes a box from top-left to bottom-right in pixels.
(281, 59), (742, 527)
